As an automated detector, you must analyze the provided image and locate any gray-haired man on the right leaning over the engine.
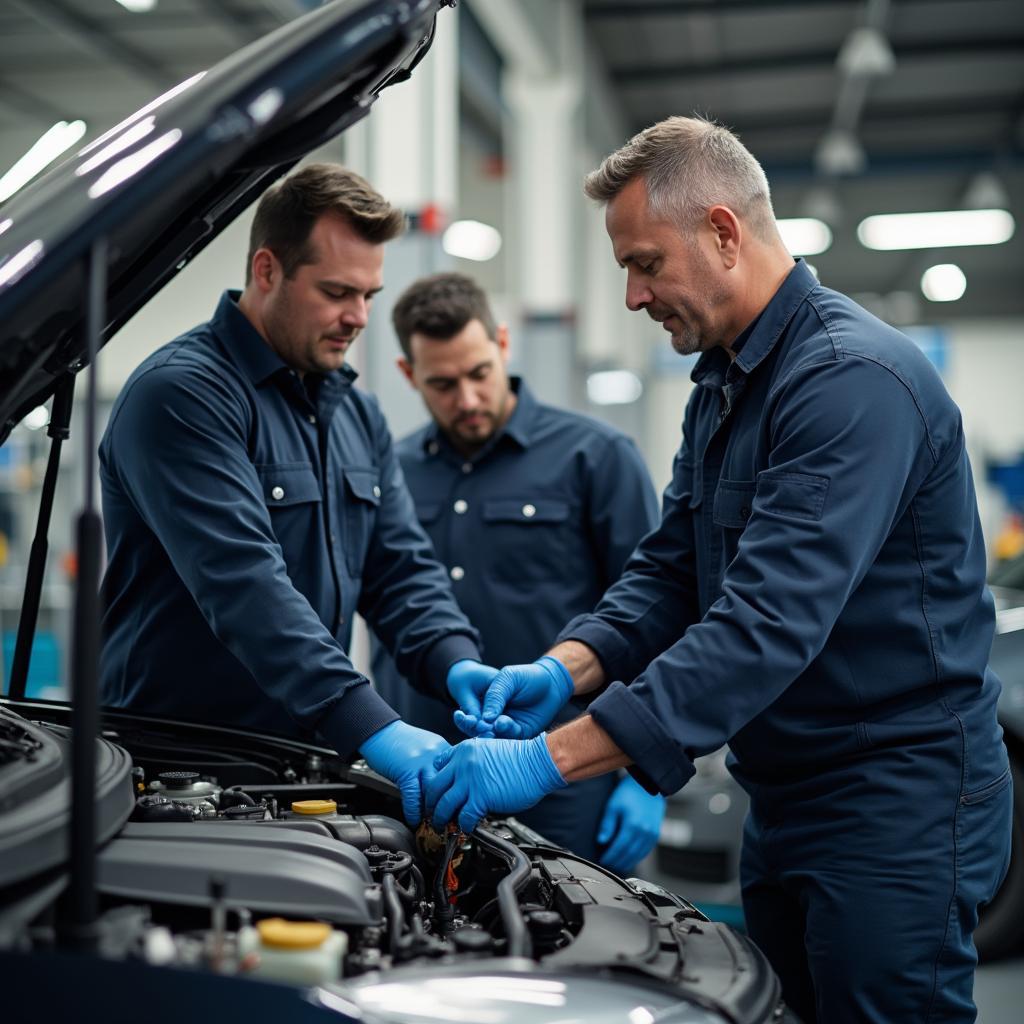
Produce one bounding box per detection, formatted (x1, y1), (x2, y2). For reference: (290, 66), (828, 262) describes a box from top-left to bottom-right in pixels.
(426, 118), (1012, 1024)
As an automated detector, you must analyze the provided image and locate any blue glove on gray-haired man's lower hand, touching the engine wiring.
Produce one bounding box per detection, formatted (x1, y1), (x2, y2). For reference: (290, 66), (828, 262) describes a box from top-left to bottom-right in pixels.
(424, 732), (566, 833)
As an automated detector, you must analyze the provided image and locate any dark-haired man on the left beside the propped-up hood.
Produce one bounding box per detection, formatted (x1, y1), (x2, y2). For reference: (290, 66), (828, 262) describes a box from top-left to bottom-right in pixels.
(100, 164), (494, 822)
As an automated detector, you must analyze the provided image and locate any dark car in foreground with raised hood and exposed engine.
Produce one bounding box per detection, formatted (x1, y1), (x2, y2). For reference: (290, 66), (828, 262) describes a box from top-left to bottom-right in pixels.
(0, 0), (793, 1024)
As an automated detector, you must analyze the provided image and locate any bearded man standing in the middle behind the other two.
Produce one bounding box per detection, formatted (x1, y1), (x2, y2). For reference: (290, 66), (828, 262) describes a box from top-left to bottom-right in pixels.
(373, 273), (665, 874)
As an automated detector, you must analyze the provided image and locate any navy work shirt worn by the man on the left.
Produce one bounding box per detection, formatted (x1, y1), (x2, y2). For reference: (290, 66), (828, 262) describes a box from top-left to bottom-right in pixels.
(99, 293), (478, 754)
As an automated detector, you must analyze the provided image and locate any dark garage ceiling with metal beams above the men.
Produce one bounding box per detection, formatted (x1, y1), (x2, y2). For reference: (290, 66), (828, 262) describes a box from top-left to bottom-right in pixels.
(0, 0), (1024, 323)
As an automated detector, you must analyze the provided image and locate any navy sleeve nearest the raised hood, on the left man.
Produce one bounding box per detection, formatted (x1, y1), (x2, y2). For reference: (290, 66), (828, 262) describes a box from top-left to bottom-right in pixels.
(110, 365), (397, 754)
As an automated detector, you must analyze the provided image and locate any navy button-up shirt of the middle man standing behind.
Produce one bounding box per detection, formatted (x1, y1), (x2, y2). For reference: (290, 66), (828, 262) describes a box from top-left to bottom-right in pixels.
(374, 378), (657, 738)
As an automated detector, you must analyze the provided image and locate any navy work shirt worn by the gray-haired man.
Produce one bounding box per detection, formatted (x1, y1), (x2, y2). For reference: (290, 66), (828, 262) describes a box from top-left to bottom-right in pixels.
(560, 262), (1006, 797)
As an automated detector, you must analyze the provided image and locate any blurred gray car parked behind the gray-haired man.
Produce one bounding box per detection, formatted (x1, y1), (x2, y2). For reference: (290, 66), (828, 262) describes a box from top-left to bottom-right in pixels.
(644, 555), (1024, 959)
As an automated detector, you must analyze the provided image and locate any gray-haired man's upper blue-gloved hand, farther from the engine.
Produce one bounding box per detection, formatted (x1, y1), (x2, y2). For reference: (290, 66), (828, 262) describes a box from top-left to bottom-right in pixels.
(456, 654), (572, 739)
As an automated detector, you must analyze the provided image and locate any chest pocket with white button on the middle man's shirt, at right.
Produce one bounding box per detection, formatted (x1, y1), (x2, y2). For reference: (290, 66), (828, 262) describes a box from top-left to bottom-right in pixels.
(482, 498), (573, 583)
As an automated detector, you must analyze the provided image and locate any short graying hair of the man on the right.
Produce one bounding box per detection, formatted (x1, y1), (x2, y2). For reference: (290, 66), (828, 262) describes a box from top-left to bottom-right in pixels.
(583, 117), (777, 242)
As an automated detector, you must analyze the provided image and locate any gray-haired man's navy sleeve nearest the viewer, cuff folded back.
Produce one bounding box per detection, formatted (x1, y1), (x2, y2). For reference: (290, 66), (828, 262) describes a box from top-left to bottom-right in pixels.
(592, 357), (941, 793)
